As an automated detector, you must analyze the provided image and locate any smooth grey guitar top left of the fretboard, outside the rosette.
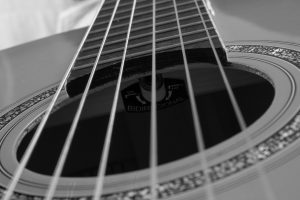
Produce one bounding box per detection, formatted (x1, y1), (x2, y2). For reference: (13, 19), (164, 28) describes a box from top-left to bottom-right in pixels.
(0, 29), (86, 108)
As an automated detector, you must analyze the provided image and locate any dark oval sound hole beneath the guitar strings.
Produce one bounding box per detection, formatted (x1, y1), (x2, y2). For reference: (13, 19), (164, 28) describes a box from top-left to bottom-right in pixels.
(17, 65), (274, 177)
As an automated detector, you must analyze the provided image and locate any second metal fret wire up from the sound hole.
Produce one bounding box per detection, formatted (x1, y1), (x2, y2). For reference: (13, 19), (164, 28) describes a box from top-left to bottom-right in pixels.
(77, 27), (213, 61)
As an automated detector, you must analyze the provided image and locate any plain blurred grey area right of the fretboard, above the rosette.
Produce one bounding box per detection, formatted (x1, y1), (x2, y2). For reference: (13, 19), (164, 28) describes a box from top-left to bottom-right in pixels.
(210, 0), (300, 43)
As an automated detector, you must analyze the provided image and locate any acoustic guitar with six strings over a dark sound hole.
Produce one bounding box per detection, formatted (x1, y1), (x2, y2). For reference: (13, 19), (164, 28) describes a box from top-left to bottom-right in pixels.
(0, 0), (300, 200)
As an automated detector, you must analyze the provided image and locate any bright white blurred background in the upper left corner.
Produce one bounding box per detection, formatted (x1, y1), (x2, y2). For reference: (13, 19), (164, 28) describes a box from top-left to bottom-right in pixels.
(0, 0), (101, 49)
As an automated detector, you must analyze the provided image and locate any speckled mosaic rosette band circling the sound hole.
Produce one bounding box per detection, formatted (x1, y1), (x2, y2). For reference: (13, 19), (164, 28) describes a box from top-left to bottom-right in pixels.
(0, 41), (300, 200)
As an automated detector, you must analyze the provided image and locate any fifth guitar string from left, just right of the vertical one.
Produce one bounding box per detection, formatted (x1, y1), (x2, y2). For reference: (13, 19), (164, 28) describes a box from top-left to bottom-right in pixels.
(173, 0), (215, 200)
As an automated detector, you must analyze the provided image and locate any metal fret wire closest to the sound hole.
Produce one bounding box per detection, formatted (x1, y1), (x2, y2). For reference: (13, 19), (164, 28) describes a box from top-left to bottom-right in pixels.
(75, 36), (218, 70)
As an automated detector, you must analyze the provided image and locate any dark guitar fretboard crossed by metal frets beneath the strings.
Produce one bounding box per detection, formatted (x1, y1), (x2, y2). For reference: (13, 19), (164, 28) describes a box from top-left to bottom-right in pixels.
(71, 0), (225, 69)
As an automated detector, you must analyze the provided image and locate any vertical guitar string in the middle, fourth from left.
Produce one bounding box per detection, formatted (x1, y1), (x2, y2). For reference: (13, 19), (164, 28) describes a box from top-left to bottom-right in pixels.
(150, 0), (158, 200)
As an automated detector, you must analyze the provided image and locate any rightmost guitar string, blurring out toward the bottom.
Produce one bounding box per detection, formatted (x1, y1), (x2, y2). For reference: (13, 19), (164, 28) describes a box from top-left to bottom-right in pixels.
(194, 0), (276, 200)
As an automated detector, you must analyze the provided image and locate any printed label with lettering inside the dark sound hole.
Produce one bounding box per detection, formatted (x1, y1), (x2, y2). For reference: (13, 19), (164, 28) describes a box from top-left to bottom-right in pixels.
(121, 78), (188, 113)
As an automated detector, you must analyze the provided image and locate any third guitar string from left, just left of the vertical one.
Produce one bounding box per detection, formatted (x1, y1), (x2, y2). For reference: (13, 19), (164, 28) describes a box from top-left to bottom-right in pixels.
(93, 0), (137, 200)
